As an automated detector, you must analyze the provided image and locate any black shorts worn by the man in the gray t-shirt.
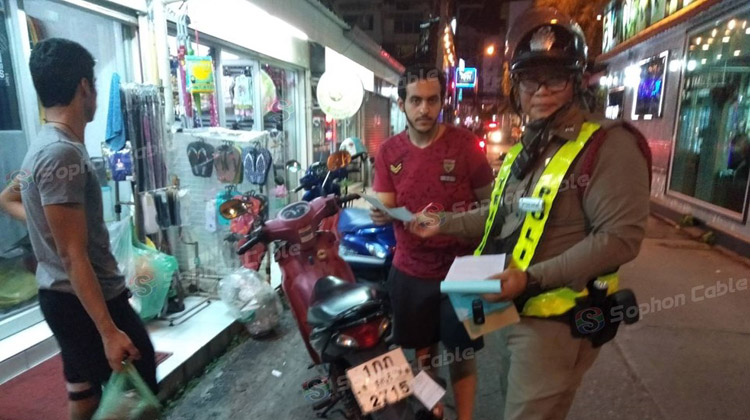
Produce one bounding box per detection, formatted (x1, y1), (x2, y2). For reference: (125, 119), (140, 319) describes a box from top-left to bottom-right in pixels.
(39, 289), (158, 394)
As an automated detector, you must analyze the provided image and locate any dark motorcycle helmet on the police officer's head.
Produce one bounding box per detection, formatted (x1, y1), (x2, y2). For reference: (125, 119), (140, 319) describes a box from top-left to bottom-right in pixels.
(506, 7), (588, 75)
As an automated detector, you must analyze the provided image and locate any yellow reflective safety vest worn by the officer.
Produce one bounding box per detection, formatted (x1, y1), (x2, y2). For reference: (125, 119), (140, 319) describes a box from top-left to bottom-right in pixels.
(474, 122), (619, 318)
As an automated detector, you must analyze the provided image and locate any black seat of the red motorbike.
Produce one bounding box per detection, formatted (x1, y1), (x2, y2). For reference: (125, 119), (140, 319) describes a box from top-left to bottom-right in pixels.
(307, 276), (380, 328)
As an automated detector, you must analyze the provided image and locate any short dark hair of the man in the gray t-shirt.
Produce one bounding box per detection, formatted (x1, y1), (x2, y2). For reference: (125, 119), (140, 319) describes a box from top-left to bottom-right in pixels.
(29, 38), (96, 108)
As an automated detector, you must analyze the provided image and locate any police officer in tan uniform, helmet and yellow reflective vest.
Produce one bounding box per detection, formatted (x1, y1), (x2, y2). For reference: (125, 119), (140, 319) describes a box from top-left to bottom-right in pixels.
(410, 8), (650, 420)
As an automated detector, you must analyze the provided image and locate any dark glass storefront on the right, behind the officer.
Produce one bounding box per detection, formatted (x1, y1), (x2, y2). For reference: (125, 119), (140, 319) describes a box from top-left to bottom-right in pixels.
(599, 0), (750, 246)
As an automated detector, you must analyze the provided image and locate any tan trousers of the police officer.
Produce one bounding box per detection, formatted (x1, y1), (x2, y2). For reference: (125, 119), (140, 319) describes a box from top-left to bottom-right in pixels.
(500, 317), (599, 420)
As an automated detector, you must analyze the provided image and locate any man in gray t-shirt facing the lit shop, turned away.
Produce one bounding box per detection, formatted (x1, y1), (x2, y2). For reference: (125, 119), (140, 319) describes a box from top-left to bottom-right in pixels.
(0, 38), (158, 420)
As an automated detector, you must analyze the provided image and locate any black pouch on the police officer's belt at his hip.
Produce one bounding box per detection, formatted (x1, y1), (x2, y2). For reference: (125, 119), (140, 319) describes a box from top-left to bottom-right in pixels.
(567, 280), (640, 347)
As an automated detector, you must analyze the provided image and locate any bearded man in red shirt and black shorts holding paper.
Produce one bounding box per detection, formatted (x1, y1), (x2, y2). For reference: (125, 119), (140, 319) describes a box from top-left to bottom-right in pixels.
(371, 65), (493, 420)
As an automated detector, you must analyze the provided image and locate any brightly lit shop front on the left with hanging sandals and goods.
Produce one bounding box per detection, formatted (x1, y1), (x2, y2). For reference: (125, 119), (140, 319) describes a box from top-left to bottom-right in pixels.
(0, 0), (401, 396)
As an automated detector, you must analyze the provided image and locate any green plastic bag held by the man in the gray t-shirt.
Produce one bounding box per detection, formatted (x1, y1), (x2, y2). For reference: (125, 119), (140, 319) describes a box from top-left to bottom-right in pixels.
(93, 363), (161, 420)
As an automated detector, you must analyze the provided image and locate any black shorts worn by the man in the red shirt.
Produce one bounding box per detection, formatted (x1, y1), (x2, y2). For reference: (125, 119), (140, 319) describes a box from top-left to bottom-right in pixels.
(388, 267), (484, 353)
